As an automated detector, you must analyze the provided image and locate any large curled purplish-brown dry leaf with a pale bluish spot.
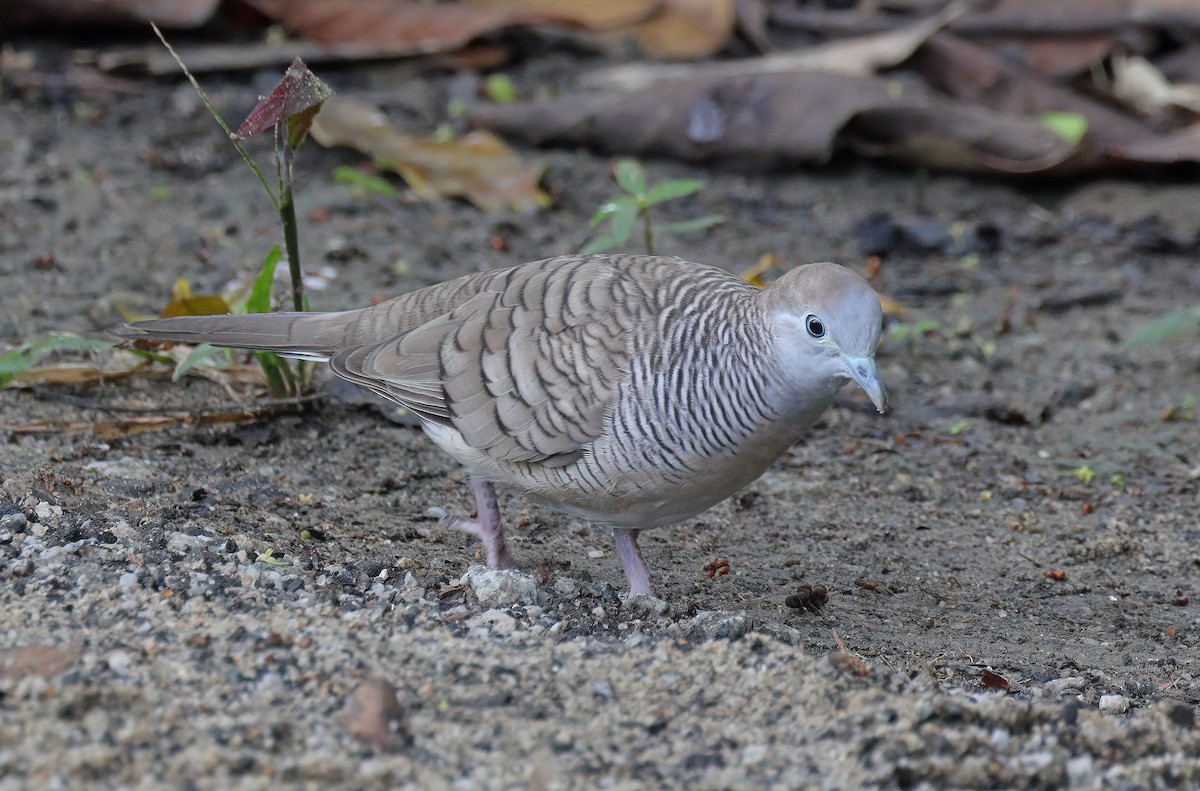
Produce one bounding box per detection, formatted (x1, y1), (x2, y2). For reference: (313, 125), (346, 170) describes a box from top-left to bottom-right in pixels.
(472, 72), (1076, 173)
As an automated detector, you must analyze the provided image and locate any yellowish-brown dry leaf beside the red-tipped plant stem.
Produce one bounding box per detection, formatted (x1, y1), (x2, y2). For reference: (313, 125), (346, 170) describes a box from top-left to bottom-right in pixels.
(312, 96), (548, 211)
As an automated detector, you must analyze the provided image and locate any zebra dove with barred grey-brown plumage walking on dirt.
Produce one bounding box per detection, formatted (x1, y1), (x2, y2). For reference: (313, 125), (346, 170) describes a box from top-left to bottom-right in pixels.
(116, 256), (884, 593)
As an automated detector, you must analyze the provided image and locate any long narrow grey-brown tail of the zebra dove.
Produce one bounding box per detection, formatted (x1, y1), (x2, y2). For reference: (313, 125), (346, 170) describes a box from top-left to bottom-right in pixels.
(112, 311), (360, 360)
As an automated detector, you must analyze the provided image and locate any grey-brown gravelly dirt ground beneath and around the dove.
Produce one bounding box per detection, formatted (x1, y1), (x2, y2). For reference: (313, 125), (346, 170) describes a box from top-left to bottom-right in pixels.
(0, 42), (1200, 789)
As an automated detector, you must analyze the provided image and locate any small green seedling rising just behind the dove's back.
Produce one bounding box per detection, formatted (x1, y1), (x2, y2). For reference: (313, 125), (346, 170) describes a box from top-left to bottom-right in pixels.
(580, 158), (725, 256)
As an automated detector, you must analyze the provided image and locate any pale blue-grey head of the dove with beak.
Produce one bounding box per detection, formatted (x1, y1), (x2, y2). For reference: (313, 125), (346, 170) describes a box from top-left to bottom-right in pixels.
(767, 263), (886, 412)
